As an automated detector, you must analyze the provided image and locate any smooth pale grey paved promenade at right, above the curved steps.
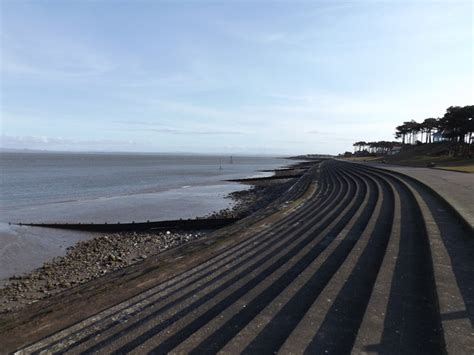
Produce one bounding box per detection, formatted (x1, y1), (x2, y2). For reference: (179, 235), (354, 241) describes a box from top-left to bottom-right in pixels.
(365, 163), (474, 229)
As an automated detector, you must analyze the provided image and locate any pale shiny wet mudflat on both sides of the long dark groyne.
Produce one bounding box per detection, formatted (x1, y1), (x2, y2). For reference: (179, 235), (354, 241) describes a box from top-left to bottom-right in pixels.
(0, 184), (244, 287)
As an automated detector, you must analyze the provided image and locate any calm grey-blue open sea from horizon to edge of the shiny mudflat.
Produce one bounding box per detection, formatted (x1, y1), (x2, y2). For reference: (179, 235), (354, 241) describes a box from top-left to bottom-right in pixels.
(0, 153), (286, 216)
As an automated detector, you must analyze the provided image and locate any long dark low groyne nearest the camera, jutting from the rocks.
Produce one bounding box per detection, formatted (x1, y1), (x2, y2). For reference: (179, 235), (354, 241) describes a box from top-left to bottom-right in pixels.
(12, 218), (238, 233)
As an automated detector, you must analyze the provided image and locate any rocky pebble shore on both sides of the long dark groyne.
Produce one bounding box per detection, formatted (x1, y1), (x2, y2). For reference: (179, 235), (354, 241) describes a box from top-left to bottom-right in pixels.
(0, 172), (300, 315)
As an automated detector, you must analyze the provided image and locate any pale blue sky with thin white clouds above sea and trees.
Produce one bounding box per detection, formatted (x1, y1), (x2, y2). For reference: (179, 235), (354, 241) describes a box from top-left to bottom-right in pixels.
(0, 0), (474, 154)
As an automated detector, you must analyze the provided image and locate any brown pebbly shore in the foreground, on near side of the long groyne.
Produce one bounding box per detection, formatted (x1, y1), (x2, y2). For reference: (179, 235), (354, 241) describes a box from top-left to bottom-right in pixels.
(0, 231), (204, 313)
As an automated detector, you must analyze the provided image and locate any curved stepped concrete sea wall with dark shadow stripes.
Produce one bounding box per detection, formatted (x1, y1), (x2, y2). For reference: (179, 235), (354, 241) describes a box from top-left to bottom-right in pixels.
(0, 160), (474, 354)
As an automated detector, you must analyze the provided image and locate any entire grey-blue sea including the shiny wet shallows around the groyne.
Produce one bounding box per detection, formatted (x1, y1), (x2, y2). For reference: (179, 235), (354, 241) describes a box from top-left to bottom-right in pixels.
(0, 152), (294, 286)
